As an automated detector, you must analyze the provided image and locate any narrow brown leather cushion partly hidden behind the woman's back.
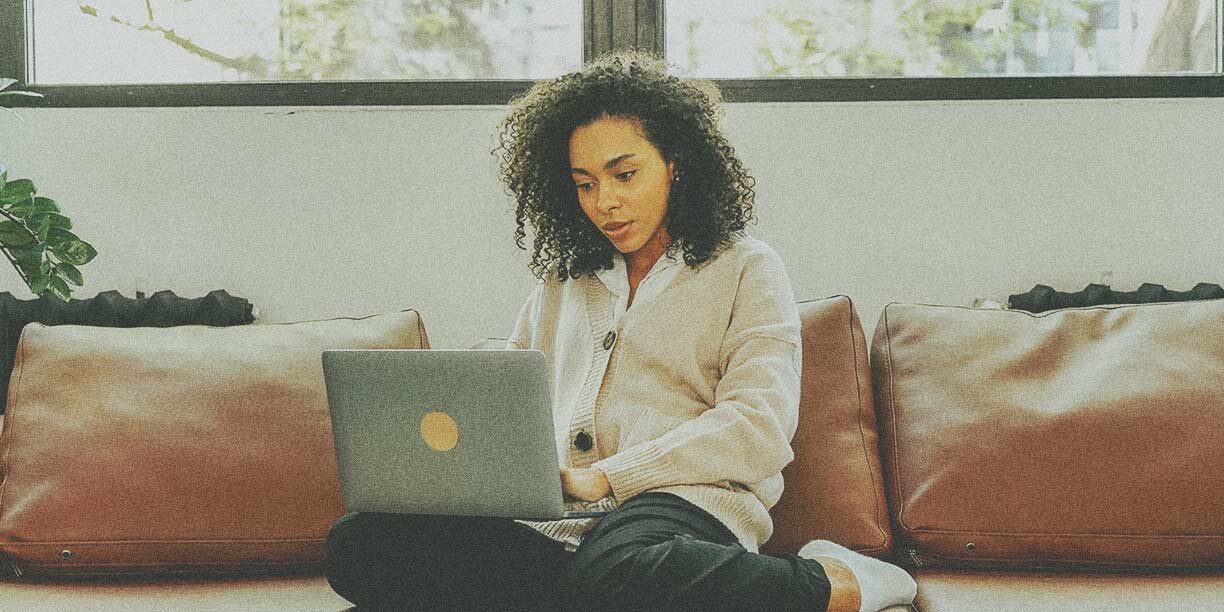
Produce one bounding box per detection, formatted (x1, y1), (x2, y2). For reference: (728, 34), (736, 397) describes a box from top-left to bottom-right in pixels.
(761, 295), (892, 557)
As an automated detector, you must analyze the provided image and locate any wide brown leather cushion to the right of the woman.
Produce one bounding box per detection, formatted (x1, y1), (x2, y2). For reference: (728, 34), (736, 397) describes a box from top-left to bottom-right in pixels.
(871, 300), (1224, 567)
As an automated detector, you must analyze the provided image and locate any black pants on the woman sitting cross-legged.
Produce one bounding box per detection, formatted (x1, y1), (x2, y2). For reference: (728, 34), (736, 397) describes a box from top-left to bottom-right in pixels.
(324, 493), (829, 612)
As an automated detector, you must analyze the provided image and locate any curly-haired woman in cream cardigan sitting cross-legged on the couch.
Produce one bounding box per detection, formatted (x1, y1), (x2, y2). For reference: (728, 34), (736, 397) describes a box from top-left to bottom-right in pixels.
(326, 54), (914, 612)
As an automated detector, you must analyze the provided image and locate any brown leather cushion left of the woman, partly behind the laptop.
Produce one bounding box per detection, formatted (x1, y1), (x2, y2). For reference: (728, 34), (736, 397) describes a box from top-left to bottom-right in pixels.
(0, 311), (428, 574)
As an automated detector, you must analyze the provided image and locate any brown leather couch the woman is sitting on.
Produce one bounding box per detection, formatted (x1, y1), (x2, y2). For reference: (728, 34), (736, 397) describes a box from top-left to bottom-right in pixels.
(0, 295), (1224, 612)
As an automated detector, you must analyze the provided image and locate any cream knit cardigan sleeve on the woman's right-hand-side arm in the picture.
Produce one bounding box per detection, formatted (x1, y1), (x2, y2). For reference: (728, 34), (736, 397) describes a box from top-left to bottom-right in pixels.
(594, 251), (802, 502)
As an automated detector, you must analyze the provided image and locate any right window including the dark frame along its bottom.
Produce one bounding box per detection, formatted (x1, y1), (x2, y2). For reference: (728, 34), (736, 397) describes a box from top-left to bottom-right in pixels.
(665, 0), (1224, 100)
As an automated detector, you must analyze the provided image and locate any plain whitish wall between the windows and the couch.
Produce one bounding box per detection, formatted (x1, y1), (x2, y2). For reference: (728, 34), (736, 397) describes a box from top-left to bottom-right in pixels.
(0, 99), (1224, 348)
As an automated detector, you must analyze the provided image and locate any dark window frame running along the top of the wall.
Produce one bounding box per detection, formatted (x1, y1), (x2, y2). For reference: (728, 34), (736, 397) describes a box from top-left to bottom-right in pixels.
(0, 0), (1224, 108)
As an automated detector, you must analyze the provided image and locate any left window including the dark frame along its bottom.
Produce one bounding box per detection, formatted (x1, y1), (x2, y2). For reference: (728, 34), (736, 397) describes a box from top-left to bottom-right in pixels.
(0, 0), (599, 106)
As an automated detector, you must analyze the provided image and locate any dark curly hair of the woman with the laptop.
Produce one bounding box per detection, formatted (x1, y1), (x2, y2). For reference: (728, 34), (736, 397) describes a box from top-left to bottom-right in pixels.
(493, 51), (755, 282)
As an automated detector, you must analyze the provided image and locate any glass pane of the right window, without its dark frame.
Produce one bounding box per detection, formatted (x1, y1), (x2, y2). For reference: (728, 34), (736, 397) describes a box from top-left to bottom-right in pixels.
(666, 0), (1218, 78)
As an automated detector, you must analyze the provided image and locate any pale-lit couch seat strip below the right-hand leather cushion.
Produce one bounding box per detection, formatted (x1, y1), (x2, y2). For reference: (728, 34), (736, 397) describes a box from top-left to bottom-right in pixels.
(914, 569), (1224, 612)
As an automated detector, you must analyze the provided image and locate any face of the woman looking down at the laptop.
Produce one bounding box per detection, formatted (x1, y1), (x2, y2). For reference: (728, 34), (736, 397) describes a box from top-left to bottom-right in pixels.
(569, 115), (676, 269)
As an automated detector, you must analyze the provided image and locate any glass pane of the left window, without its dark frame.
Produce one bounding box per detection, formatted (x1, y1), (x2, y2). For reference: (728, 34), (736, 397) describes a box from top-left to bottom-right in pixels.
(27, 0), (583, 84)
